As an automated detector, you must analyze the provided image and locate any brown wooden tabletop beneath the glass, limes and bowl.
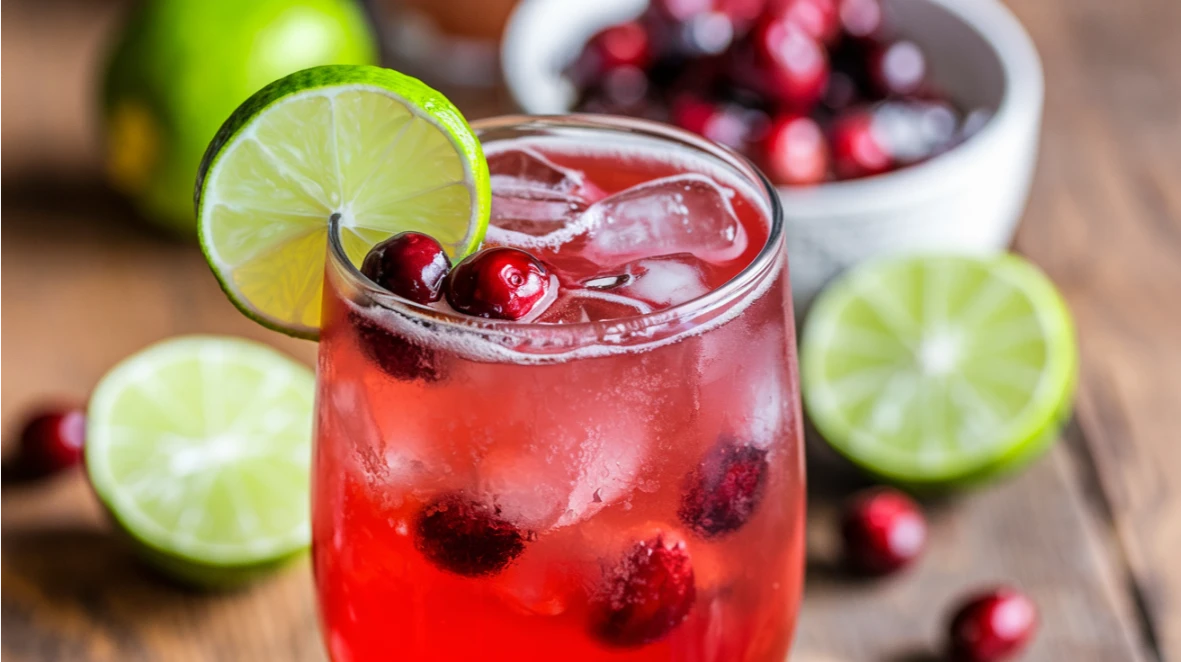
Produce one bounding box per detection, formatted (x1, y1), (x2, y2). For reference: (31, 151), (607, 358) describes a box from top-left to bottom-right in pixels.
(0, 0), (1181, 662)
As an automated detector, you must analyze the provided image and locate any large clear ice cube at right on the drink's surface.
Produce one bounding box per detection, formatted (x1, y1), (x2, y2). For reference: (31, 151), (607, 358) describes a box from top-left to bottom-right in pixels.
(579, 175), (748, 264)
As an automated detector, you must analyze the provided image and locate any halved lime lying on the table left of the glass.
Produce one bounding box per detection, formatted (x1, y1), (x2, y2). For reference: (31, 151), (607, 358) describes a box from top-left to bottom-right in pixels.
(86, 336), (314, 585)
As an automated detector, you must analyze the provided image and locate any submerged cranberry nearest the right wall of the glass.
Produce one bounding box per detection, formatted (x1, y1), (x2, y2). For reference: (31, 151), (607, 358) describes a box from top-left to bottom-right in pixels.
(677, 439), (766, 538)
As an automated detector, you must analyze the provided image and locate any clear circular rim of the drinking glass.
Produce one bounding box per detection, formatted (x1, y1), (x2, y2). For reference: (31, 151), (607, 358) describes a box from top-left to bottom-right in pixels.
(328, 113), (785, 341)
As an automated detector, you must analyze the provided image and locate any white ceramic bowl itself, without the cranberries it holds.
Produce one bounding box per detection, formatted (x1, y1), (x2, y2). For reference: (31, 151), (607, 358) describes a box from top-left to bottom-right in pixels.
(502, 0), (1044, 310)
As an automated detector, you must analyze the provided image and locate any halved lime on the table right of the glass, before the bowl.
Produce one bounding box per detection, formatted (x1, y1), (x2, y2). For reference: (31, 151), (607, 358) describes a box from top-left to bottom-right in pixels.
(800, 255), (1078, 487)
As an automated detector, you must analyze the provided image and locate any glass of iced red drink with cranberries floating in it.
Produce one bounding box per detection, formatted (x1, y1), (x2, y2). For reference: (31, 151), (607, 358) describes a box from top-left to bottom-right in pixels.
(313, 118), (804, 662)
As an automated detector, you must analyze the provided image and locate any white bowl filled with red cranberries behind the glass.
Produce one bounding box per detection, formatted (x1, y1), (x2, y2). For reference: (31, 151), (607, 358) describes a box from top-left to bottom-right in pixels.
(502, 0), (1044, 308)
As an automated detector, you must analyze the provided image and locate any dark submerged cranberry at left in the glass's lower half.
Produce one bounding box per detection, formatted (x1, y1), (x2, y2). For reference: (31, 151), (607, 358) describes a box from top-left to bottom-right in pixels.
(415, 493), (526, 577)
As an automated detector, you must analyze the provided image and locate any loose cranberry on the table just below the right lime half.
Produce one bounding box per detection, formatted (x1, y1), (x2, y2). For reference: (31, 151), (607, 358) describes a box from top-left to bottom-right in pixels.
(841, 489), (927, 575)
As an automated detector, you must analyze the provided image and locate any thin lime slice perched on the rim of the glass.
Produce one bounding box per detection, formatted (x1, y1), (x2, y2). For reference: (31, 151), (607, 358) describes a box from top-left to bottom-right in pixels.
(196, 65), (491, 339)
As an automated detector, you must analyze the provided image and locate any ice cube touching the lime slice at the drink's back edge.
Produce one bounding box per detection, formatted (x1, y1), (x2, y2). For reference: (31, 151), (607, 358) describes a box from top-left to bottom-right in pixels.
(488, 148), (602, 248)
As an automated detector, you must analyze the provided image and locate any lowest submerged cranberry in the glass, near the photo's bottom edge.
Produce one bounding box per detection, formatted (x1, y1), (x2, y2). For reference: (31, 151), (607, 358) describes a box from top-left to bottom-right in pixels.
(591, 533), (697, 647)
